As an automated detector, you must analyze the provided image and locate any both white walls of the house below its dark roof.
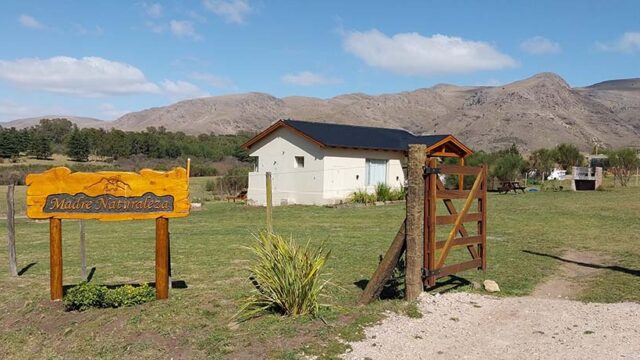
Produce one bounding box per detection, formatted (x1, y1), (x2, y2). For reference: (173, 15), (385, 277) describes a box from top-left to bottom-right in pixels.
(247, 128), (405, 206)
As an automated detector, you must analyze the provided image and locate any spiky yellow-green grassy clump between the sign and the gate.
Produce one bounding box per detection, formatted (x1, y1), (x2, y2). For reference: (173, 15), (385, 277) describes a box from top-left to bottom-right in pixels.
(236, 231), (330, 320)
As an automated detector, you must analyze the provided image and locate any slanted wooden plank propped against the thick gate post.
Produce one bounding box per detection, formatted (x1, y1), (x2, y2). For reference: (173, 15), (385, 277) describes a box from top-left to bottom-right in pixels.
(358, 219), (407, 305)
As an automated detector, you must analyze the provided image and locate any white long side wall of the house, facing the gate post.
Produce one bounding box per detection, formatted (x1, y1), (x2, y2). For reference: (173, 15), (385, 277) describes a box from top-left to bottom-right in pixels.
(324, 148), (405, 203)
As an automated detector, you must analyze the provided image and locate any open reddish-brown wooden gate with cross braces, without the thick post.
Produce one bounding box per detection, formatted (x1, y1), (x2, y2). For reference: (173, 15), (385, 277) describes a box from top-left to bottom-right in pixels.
(423, 158), (487, 287)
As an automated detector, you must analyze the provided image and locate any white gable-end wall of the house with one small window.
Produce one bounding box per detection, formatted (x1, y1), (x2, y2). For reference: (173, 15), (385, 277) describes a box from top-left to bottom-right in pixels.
(247, 128), (324, 205)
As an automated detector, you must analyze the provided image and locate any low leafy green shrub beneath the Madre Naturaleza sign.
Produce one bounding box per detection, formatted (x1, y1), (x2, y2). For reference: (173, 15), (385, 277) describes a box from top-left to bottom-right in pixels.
(64, 282), (156, 311)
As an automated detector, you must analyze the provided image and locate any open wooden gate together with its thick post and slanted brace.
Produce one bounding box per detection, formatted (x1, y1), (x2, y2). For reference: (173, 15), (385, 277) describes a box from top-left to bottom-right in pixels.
(358, 144), (487, 305)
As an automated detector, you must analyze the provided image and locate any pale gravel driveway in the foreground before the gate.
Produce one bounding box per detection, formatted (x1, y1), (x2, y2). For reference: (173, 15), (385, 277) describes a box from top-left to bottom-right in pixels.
(343, 293), (640, 360)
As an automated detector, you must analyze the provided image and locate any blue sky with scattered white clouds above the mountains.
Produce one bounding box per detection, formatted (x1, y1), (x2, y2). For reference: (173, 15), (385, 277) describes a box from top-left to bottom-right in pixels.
(0, 0), (640, 121)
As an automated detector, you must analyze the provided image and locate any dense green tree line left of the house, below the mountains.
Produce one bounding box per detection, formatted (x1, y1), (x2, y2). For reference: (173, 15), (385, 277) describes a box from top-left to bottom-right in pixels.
(0, 119), (251, 161)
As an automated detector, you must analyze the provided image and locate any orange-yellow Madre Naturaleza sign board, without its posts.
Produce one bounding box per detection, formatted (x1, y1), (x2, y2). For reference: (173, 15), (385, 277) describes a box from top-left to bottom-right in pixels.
(26, 167), (190, 220)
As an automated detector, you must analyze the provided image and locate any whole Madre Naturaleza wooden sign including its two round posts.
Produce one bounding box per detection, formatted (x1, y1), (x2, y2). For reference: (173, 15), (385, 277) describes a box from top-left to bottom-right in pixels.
(27, 162), (191, 300)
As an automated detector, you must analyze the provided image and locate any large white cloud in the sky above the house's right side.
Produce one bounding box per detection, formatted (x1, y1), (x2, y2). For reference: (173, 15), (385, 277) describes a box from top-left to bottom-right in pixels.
(343, 29), (517, 75)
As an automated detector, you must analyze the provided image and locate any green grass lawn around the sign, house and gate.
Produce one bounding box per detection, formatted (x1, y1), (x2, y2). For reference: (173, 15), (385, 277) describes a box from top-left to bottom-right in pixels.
(0, 182), (640, 359)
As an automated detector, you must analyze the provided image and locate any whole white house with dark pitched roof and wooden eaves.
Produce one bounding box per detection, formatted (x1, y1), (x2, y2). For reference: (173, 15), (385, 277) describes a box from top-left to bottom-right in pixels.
(243, 120), (471, 205)
